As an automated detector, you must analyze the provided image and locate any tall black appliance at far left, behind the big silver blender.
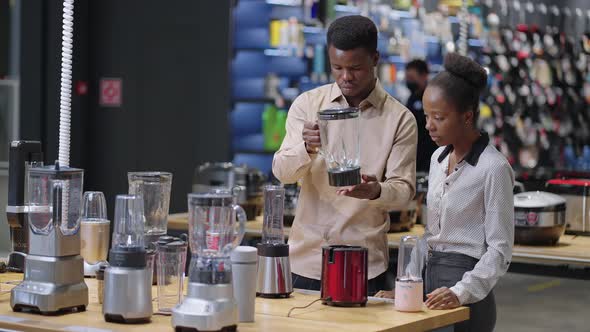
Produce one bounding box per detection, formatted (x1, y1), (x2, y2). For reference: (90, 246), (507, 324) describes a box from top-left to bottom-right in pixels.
(6, 141), (43, 272)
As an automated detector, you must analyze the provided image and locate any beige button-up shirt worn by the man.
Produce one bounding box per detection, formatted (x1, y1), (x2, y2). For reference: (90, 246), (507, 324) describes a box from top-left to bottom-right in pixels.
(272, 81), (417, 279)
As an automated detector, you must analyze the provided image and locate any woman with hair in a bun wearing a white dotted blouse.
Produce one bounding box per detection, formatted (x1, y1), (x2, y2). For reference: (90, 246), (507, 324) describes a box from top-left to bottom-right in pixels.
(382, 54), (514, 331)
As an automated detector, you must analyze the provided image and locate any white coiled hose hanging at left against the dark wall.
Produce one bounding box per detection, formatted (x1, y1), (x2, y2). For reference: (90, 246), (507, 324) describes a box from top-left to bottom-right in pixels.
(58, 0), (74, 166)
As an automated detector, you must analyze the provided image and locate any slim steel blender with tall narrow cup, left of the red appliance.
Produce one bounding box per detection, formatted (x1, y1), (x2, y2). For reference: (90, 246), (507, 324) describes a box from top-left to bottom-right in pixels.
(256, 186), (293, 298)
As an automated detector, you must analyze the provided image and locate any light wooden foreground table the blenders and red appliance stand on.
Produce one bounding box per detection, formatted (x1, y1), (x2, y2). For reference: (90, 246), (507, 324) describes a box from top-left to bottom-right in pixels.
(0, 273), (469, 332)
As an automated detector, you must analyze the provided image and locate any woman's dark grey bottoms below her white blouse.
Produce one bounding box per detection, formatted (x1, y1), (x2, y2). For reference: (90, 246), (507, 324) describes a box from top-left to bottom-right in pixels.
(425, 251), (496, 332)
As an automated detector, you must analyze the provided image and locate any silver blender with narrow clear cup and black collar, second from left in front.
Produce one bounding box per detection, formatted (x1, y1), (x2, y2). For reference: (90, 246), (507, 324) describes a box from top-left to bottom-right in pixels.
(102, 195), (152, 323)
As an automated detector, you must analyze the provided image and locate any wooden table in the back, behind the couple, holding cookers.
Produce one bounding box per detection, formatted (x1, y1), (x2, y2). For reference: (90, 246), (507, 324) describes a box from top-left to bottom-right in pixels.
(168, 213), (590, 266)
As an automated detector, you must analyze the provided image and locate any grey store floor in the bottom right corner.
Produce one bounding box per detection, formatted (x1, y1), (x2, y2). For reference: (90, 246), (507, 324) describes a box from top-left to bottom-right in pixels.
(495, 273), (590, 332)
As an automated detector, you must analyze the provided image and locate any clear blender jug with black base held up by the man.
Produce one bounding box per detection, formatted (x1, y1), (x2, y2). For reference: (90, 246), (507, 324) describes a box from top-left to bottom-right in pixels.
(318, 107), (361, 187)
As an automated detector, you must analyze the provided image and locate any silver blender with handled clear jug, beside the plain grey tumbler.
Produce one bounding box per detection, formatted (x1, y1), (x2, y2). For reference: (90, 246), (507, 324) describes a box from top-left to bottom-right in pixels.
(172, 191), (246, 331)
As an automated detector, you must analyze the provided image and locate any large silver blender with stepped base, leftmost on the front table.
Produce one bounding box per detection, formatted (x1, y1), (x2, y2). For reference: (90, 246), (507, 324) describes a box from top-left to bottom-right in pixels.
(10, 162), (88, 314)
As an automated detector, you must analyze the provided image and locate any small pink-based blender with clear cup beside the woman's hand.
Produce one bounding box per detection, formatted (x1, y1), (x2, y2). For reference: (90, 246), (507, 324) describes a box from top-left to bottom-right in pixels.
(395, 235), (426, 312)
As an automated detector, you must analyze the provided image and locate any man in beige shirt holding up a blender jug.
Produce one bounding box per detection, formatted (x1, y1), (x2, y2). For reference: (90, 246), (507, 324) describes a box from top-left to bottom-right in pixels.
(272, 16), (417, 294)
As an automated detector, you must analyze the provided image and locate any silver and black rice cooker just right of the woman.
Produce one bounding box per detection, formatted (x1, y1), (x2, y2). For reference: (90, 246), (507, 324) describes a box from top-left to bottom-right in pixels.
(514, 191), (566, 245)
